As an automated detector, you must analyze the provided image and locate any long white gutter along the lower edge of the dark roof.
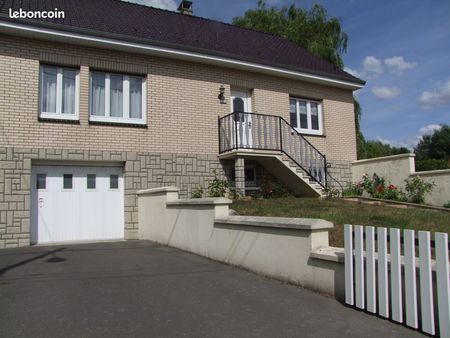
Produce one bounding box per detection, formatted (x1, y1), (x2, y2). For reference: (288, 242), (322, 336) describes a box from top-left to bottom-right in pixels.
(0, 17), (365, 90)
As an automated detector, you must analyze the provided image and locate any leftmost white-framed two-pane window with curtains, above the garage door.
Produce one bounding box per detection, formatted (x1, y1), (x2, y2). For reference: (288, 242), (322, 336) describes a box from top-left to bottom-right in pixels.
(39, 65), (80, 120)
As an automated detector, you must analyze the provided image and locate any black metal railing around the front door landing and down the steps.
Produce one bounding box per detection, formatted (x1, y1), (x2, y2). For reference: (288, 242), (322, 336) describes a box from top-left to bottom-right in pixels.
(219, 112), (327, 188)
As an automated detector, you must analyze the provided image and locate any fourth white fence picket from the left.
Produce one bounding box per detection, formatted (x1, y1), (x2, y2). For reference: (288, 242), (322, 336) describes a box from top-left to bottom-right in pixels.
(377, 228), (389, 318)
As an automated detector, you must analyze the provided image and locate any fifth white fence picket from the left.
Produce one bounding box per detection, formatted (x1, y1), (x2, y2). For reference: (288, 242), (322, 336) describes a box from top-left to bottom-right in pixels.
(389, 228), (403, 323)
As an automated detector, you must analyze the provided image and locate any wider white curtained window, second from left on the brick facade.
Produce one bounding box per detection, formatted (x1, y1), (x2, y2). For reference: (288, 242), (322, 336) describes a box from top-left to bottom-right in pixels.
(90, 71), (146, 124)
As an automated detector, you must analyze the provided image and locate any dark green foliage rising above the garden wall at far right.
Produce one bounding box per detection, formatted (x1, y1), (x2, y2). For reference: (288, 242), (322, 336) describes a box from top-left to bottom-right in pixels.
(414, 124), (450, 163)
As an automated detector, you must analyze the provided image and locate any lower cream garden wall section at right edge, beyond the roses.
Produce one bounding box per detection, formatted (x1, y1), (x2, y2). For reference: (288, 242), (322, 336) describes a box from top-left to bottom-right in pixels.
(410, 169), (450, 207)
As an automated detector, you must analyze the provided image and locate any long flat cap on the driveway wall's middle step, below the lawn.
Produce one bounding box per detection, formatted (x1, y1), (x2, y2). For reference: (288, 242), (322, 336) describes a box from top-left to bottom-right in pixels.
(214, 216), (334, 230)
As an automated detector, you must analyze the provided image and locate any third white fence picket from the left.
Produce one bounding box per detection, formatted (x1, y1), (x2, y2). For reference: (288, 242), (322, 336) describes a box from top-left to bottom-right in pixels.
(366, 226), (377, 313)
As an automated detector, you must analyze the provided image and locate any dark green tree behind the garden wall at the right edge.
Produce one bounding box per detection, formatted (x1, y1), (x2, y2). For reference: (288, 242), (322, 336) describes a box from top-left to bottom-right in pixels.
(414, 124), (450, 171)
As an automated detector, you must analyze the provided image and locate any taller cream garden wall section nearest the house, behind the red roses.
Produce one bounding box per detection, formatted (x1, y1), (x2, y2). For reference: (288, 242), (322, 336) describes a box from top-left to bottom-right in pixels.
(352, 153), (416, 188)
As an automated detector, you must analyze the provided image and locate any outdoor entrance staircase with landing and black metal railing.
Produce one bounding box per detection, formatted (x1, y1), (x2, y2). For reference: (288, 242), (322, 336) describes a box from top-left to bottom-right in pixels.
(219, 112), (327, 197)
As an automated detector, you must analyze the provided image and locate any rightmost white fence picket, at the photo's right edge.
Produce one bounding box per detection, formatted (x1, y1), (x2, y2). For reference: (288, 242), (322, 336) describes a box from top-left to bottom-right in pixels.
(435, 232), (450, 338)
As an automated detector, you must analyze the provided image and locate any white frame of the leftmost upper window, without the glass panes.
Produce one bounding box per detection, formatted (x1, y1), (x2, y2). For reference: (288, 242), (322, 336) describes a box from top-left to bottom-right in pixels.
(39, 64), (80, 121)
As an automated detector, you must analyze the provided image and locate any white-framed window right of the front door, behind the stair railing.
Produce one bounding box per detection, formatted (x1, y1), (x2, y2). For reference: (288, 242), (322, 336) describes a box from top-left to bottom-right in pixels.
(289, 98), (323, 135)
